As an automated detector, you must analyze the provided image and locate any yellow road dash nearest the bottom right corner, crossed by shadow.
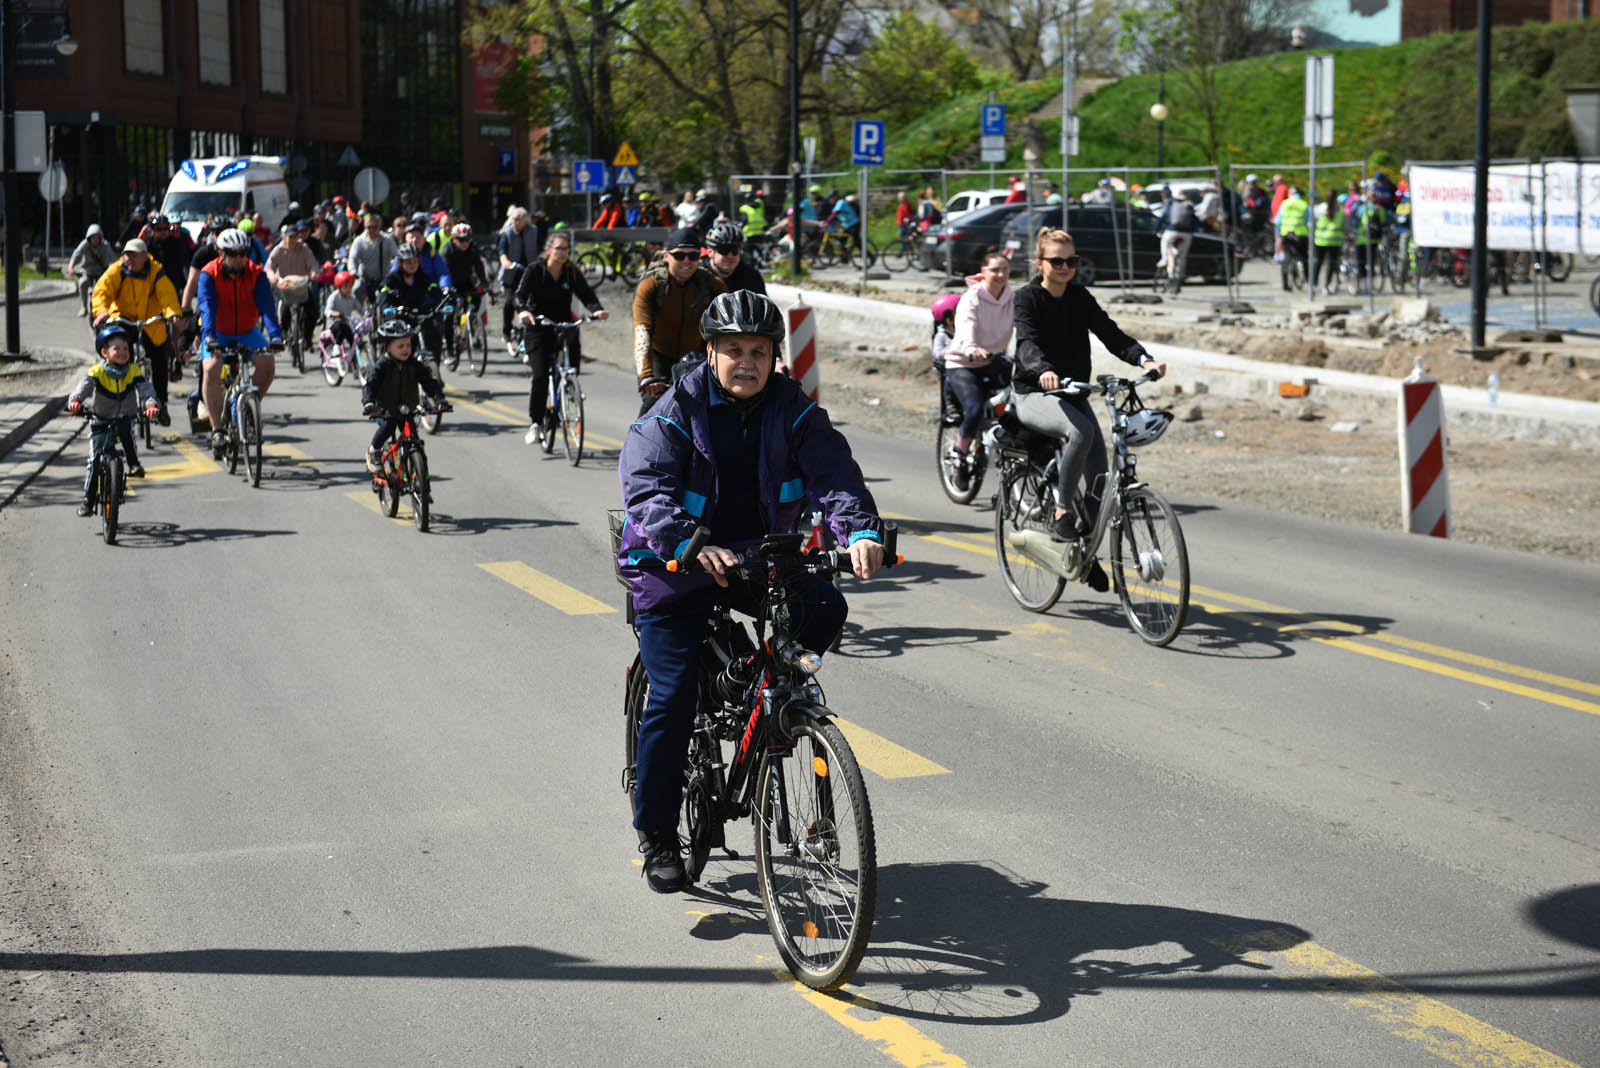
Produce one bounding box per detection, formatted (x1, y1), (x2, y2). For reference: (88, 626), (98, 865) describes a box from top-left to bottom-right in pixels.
(1227, 931), (1578, 1068)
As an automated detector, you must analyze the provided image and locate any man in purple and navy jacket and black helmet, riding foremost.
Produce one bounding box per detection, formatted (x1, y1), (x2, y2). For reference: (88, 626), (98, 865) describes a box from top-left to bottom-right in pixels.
(618, 291), (883, 894)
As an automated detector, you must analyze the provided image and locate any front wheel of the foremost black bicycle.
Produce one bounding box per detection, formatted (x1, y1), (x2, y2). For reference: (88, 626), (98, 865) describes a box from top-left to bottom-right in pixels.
(755, 723), (878, 990)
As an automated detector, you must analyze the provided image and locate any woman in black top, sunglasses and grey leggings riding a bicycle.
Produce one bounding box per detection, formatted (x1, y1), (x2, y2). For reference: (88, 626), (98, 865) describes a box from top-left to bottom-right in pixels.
(1011, 229), (1166, 556)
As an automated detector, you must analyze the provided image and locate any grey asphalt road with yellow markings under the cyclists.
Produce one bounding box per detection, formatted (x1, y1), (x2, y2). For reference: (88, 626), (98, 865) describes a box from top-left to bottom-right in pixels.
(0, 301), (1600, 1068)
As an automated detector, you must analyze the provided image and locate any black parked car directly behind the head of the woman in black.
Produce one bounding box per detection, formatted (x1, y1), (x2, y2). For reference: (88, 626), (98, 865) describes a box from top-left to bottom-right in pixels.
(992, 205), (1227, 286)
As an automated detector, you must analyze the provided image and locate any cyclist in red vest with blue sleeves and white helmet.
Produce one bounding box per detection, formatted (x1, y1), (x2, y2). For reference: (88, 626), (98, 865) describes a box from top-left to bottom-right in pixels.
(197, 230), (283, 457)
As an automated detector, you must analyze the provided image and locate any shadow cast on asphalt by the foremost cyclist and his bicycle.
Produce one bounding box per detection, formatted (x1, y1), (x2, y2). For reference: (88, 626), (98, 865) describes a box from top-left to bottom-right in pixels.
(691, 862), (1310, 1025)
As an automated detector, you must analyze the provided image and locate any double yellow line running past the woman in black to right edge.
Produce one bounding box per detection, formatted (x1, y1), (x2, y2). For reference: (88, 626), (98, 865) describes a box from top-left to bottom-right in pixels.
(885, 513), (1600, 715)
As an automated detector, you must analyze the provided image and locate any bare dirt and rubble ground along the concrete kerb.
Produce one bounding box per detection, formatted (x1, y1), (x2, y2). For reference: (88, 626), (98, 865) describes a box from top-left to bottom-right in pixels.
(806, 312), (1600, 563)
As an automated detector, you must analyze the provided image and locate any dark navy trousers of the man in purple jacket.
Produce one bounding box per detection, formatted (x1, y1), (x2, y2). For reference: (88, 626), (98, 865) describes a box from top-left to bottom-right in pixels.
(634, 576), (848, 831)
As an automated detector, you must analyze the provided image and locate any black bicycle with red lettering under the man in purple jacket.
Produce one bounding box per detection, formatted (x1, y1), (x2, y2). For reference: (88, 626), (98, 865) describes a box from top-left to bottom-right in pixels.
(608, 521), (898, 990)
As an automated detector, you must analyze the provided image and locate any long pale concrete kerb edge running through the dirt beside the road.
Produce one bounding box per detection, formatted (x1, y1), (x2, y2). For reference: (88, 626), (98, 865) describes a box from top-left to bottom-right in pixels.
(768, 285), (1600, 448)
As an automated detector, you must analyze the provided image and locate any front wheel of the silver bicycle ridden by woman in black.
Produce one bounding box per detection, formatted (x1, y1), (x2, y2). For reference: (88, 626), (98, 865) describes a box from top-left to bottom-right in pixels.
(1110, 486), (1189, 646)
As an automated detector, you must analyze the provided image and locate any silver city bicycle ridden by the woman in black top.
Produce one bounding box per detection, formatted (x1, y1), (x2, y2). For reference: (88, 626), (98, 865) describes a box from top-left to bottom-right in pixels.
(987, 374), (1189, 646)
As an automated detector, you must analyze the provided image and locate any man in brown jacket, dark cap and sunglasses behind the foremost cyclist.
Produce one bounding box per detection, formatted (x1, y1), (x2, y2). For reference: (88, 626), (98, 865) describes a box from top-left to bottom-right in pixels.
(634, 229), (728, 414)
